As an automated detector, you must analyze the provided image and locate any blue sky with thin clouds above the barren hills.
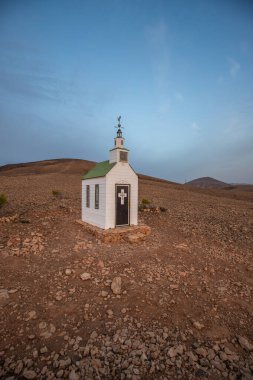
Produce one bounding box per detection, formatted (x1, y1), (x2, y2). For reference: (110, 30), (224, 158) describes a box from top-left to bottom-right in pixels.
(0, 0), (253, 183)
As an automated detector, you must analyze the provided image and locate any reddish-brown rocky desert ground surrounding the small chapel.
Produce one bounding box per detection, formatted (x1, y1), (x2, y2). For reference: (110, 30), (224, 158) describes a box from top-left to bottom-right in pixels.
(0, 160), (253, 380)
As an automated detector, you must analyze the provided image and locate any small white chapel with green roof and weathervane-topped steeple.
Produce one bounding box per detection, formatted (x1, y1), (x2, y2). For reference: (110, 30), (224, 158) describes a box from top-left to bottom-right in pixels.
(82, 116), (138, 229)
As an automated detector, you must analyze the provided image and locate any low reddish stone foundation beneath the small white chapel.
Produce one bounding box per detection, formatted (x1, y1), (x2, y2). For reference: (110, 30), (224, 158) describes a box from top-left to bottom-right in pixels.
(76, 220), (151, 244)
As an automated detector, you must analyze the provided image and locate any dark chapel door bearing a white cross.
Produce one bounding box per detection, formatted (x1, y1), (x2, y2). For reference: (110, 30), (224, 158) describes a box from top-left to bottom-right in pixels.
(116, 185), (129, 226)
